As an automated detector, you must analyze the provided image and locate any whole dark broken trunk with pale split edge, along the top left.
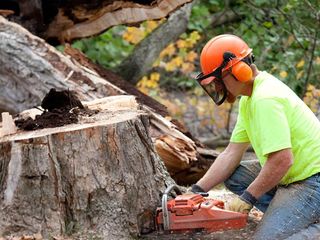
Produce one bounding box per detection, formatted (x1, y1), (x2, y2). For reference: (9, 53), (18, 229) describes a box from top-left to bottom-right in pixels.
(0, 0), (192, 43)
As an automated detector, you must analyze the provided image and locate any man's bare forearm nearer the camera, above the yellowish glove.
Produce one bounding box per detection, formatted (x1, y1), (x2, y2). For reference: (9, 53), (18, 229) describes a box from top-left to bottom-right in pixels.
(247, 148), (293, 199)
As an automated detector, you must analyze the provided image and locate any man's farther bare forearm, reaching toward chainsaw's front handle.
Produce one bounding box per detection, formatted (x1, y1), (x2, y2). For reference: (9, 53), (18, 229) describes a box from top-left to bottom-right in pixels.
(197, 143), (249, 192)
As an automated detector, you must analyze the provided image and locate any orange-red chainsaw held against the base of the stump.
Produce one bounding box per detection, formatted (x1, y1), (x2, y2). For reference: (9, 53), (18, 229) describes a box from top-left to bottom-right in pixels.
(156, 185), (248, 232)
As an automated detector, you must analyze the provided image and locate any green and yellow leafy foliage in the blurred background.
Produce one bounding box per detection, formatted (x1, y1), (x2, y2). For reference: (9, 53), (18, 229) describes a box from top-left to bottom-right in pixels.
(65, 0), (320, 99)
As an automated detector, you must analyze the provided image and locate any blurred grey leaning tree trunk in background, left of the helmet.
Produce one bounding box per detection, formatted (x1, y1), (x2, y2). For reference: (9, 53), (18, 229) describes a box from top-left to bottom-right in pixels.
(118, 3), (193, 84)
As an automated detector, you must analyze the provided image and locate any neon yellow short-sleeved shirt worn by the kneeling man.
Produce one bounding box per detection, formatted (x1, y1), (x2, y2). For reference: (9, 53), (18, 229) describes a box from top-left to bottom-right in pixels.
(230, 72), (320, 185)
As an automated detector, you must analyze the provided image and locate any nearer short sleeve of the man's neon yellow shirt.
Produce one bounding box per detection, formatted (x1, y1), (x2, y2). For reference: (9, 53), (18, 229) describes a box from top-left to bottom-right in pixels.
(253, 99), (292, 156)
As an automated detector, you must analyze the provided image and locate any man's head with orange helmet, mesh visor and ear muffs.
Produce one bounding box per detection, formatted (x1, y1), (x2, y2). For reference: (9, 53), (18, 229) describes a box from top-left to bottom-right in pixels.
(197, 34), (254, 105)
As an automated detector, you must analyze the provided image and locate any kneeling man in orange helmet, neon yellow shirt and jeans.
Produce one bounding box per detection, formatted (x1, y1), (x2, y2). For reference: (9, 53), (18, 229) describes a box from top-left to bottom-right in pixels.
(192, 34), (320, 240)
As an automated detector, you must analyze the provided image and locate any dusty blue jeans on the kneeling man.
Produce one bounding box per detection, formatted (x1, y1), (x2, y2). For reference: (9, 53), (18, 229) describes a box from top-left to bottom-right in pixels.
(225, 160), (320, 240)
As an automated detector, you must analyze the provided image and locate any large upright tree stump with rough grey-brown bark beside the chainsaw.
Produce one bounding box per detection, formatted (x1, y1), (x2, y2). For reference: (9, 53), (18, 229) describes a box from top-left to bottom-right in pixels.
(0, 96), (172, 239)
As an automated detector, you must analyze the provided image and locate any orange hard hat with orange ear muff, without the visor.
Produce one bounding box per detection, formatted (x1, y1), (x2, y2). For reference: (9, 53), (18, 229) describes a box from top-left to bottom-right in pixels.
(200, 34), (252, 84)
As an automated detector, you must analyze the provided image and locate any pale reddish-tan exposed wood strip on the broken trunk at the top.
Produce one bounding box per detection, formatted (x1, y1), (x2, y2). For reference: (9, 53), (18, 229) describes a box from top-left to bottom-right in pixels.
(46, 0), (191, 41)
